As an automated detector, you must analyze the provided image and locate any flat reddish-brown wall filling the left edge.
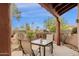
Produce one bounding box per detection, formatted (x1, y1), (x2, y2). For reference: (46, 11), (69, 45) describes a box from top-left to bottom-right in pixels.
(0, 3), (10, 56)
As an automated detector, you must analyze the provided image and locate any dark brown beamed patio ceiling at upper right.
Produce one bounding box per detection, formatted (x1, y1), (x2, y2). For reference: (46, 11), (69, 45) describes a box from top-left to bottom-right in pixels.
(40, 3), (77, 15)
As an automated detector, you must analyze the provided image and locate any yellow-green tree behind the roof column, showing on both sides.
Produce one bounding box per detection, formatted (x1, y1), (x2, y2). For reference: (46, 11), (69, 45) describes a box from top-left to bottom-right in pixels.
(44, 18), (70, 32)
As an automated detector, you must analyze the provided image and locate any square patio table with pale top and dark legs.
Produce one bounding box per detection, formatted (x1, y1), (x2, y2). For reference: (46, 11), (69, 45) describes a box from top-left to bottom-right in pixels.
(31, 39), (53, 56)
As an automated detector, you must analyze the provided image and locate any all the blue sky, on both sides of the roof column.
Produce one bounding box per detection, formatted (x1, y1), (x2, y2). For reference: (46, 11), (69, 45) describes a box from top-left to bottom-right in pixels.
(12, 3), (77, 28)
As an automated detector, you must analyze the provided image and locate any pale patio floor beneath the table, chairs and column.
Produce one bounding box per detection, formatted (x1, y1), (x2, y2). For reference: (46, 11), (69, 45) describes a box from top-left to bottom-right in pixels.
(11, 44), (79, 56)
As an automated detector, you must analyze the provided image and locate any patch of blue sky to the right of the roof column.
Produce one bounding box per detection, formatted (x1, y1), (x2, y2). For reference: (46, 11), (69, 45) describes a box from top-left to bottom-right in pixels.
(61, 7), (77, 26)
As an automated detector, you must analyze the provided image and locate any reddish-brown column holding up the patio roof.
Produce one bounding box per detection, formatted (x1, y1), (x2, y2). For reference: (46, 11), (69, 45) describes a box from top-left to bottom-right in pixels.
(56, 17), (60, 45)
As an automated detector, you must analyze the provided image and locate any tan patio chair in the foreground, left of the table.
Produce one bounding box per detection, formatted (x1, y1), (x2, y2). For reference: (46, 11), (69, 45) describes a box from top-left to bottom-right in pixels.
(18, 32), (39, 56)
